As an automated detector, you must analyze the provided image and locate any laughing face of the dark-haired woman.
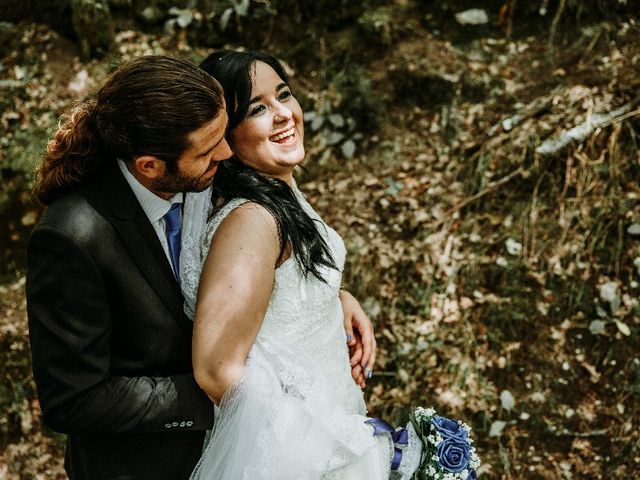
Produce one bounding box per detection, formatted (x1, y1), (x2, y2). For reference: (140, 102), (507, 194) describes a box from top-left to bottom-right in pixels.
(230, 62), (304, 182)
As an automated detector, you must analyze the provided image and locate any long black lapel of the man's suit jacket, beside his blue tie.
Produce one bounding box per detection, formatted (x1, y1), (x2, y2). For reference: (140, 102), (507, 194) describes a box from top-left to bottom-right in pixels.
(95, 167), (192, 330)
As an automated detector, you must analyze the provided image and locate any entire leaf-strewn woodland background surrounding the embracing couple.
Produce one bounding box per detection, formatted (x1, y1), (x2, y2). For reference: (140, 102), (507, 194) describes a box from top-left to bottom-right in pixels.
(0, 0), (640, 480)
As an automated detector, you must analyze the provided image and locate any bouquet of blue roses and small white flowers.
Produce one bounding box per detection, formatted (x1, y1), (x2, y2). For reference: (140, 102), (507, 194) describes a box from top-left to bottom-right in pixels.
(410, 407), (480, 480)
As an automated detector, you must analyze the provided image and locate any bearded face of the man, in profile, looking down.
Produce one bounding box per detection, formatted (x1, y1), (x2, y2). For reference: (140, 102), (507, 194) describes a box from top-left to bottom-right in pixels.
(153, 108), (231, 193)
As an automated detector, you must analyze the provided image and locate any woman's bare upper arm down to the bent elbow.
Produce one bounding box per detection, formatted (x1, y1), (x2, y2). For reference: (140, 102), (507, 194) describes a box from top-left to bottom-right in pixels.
(192, 203), (279, 405)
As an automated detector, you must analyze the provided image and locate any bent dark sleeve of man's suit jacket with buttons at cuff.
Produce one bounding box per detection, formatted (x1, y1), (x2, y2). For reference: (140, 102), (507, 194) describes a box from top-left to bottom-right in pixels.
(27, 227), (213, 433)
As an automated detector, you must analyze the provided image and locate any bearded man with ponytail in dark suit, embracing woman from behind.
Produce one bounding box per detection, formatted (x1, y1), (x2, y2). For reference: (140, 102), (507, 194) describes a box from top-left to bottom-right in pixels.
(27, 56), (375, 480)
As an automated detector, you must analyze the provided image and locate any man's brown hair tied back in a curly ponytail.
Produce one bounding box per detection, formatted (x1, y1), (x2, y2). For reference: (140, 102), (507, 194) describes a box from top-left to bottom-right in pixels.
(34, 55), (224, 205)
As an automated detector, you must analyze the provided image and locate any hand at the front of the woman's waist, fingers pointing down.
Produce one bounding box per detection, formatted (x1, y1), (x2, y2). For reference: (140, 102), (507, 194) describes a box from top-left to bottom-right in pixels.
(340, 290), (377, 388)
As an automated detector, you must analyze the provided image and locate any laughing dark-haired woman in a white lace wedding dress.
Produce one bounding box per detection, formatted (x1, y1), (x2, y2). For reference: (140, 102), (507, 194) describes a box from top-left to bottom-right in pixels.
(181, 51), (421, 480)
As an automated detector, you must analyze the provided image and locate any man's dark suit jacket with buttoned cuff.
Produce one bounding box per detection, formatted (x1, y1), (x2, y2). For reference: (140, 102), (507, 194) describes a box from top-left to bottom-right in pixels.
(27, 166), (213, 480)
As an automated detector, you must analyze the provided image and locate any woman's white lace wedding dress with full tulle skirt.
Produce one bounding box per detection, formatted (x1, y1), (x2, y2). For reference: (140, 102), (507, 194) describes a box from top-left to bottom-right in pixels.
(180, 189), (419, 480)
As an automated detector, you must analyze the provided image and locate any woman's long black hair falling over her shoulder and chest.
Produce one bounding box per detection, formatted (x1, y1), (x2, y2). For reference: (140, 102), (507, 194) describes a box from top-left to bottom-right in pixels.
(200, 50), (337, 282)
